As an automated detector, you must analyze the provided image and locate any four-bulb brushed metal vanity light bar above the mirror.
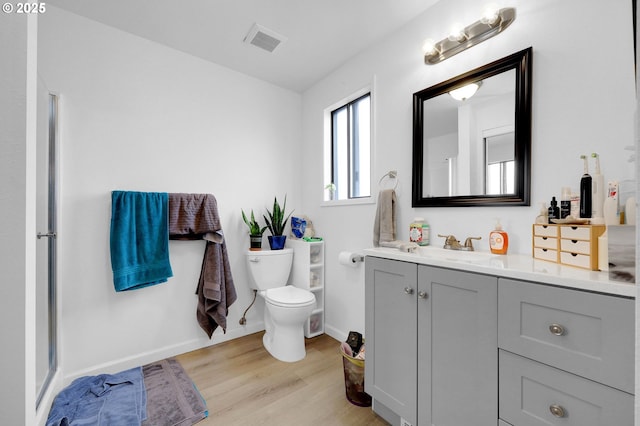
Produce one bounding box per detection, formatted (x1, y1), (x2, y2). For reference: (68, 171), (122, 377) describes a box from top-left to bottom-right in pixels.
(422, 6), (516, 65)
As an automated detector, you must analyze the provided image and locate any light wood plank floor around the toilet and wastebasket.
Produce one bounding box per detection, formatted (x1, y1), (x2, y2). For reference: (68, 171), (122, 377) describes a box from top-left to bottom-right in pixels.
(176, 332), (388, 426)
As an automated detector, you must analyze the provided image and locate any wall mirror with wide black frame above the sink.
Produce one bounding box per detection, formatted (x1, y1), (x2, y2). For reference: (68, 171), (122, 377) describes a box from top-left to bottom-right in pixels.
(412, 48), (532, 207)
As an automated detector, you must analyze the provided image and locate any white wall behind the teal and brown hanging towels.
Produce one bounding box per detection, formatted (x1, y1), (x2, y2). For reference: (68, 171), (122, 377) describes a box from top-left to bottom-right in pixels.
(38, 5), (302, 381)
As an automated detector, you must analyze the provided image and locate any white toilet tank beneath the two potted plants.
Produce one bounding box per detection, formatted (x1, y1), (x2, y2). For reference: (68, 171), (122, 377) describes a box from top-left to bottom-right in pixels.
(246, 248), (293, 290)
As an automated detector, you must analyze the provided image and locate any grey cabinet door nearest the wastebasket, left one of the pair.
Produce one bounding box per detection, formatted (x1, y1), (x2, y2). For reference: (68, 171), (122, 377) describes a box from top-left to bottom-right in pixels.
(365, 257), (418, 425)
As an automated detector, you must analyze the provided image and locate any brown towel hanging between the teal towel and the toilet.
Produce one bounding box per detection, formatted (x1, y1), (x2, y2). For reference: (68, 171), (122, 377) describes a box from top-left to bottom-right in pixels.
(169, 193), (237, 338)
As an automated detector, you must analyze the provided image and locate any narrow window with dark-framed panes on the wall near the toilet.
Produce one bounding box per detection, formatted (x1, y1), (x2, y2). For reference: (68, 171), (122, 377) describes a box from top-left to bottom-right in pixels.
(325, 93), (371, 200)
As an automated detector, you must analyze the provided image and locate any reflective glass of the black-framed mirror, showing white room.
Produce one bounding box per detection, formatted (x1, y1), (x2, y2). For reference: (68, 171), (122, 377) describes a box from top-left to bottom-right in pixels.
(422, 70), (515, 197)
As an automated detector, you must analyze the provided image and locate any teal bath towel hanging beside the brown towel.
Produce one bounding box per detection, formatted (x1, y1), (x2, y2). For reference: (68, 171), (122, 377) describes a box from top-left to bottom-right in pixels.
(111, 191), (173, 291)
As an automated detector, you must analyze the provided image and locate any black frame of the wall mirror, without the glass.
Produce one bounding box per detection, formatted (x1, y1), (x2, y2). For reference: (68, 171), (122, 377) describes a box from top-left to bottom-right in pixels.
(411, 47), (533, 207)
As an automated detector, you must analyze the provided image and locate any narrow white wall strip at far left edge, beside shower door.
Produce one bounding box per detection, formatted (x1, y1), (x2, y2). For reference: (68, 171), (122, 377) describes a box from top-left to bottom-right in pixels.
(0, 13), (37, 425)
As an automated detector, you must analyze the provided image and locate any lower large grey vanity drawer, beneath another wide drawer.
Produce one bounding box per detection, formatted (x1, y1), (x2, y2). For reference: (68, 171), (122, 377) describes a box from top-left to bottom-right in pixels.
(499, 350), (634, 426)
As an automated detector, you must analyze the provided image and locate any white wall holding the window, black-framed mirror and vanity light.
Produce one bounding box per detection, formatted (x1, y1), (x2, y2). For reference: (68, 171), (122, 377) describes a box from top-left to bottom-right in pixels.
(302, 0), (636, 338)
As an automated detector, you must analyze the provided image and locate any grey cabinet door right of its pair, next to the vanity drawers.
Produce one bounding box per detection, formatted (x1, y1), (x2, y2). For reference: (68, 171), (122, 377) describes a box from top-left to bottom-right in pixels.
(418, 265), (498, 426)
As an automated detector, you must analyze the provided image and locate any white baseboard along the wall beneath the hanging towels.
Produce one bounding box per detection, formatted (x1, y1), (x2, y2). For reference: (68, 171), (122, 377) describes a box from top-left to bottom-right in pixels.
(64, 321), (264, 386)
